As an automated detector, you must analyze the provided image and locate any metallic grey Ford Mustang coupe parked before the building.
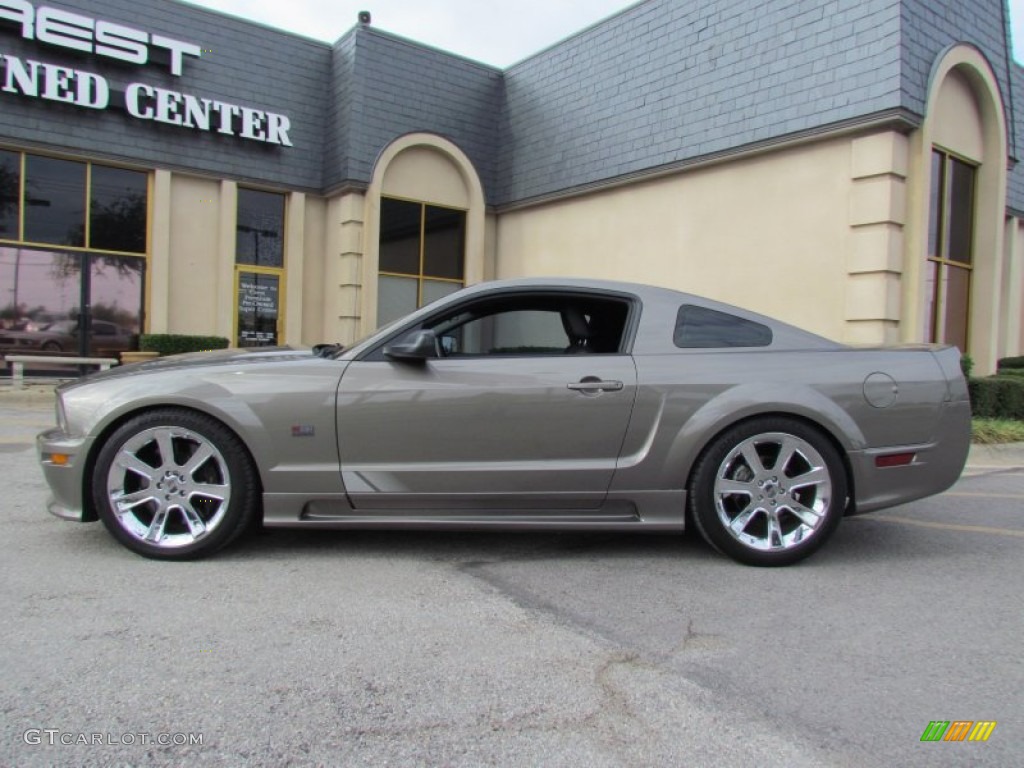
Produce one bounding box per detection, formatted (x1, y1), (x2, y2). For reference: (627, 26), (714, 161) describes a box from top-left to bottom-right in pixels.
(38, 279), (970, 565)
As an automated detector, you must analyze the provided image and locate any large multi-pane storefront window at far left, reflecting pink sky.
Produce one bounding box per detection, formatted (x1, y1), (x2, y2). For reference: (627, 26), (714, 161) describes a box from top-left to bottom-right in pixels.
(0, 151), (148, 368)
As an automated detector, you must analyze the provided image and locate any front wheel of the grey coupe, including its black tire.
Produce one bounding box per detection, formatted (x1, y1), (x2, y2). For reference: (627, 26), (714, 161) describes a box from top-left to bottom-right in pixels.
(92, 409), (260, 560)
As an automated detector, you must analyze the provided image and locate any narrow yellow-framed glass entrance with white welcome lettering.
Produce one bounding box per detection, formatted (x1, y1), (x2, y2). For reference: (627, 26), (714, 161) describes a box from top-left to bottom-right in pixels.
(234, 189), (285, 347)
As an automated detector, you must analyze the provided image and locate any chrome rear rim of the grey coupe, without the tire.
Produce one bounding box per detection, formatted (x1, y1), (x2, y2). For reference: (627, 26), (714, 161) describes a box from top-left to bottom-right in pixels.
(715, 432), (833, 551)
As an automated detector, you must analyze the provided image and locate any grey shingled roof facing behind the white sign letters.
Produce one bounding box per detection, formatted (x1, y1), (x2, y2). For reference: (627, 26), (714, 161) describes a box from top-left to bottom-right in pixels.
(0, 0), (1024, 210)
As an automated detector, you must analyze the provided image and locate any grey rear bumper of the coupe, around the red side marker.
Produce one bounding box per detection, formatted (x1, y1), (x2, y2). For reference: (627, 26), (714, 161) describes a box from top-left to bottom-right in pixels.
(847, 400), (971, 515)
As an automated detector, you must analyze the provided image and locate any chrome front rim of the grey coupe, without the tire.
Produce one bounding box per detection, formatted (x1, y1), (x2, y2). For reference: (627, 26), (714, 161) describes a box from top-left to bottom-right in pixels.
(106, 426), (231, 549)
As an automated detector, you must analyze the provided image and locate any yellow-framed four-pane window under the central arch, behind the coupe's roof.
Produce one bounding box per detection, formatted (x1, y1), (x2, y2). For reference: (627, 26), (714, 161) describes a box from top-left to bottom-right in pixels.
(377, 198), (466, 325)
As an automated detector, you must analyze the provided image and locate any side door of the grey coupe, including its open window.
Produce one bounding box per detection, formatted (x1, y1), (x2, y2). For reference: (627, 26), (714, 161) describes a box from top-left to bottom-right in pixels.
(337, 296), (636, 514)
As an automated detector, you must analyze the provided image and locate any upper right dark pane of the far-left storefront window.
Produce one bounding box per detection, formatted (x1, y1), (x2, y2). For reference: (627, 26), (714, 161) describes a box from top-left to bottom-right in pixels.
(89, 165), (146, 253)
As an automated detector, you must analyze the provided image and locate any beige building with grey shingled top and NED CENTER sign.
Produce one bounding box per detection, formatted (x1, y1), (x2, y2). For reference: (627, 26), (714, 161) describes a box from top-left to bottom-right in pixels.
(0, 0), (1024, 371)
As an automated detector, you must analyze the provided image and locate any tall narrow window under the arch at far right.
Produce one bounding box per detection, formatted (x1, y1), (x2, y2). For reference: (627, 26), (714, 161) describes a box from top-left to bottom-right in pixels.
(925, 150), (976, 352)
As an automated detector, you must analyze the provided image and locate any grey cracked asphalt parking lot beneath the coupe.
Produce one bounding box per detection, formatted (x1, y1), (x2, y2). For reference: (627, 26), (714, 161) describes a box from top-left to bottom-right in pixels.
(0, 391), (1024, 768)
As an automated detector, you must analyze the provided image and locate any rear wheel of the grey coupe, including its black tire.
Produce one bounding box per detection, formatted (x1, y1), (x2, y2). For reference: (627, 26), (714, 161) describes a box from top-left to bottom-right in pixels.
(689, 417), (847, 566)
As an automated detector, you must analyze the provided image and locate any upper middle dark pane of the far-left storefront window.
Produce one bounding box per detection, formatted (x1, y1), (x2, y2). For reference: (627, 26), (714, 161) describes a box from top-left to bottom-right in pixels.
(25, 155), (85, 246)
